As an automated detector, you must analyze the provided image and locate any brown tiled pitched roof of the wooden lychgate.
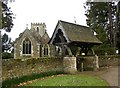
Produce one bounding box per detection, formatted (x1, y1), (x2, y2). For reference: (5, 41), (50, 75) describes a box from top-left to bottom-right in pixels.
(49, 20), (102, 44)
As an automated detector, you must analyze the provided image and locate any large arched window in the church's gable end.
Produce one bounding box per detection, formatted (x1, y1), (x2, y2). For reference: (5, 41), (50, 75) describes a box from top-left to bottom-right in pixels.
(22, 38), (31, 54)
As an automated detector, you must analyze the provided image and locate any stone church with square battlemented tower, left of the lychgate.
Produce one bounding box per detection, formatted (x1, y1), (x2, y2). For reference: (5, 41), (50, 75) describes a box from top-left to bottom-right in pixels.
(14, 23), (52, 59)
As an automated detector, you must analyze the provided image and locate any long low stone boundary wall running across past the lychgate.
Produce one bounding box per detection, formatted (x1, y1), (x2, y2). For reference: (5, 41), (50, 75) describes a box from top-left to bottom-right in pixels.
(2, 56), (120, 80)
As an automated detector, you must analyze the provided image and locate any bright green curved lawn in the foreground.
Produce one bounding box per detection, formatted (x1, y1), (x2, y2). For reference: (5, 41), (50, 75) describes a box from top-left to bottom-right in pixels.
(25, 74), (108, 86)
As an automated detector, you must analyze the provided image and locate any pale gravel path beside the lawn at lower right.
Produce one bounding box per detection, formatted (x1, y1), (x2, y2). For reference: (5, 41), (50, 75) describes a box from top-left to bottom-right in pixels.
(82, 66), (120, 88)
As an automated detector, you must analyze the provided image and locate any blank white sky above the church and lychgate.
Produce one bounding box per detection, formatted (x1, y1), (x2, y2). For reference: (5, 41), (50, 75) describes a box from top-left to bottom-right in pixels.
(8, 0), (86, 40)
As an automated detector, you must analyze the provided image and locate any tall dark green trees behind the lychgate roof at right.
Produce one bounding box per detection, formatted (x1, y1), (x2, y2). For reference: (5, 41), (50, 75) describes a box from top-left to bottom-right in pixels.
(85, 2), (117, 53)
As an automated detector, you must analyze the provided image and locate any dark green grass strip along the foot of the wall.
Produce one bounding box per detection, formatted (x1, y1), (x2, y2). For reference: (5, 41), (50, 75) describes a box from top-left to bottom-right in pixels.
(2, 71), (63, 88)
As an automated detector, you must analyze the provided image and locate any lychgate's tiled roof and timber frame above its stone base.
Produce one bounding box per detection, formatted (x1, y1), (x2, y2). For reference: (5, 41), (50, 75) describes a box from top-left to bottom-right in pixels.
(49, 20), (102, 57)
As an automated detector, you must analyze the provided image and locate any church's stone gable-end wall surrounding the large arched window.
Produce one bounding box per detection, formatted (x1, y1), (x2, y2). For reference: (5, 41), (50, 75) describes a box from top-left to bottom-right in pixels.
(14, 29), (39, 59)
